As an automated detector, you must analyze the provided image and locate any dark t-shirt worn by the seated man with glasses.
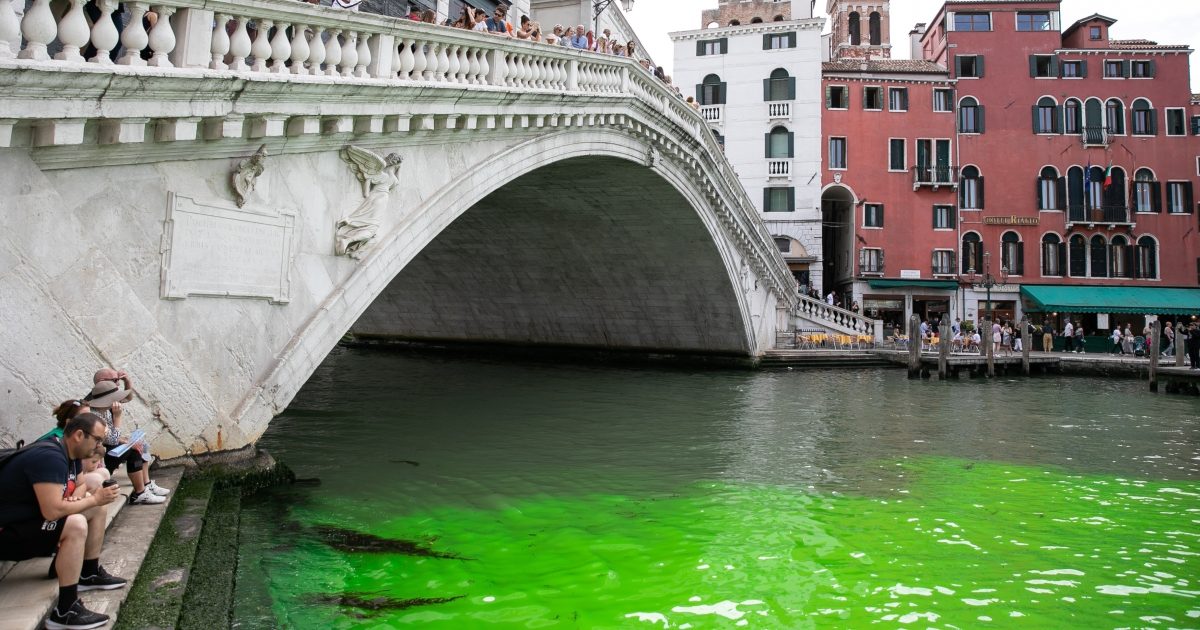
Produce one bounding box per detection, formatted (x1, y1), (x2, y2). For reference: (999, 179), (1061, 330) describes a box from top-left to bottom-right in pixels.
(0, 440), (80, 527)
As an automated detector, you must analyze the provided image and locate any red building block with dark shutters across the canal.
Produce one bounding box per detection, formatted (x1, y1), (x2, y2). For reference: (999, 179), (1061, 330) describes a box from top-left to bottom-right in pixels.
(822, 0), (1200, 331)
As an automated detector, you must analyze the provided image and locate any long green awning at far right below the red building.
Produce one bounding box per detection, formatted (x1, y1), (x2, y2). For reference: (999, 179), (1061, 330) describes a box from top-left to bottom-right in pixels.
(1021, 284), (1200, 316)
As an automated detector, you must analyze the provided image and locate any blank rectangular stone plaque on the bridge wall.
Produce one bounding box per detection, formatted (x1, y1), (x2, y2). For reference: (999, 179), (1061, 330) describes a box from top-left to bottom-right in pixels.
(161, 193), (295, 304)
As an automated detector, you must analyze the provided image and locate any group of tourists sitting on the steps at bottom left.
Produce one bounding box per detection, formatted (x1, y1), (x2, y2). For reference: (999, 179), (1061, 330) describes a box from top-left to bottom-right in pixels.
(0, 368), (170, 630)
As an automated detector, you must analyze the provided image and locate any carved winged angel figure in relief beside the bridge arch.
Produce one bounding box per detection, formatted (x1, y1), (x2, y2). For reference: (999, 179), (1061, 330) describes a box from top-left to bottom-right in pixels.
(334, 145), (403, 259)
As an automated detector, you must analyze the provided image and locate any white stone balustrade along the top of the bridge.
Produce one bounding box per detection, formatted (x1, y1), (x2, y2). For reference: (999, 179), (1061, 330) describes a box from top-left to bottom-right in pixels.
(0, 0), (796, 306)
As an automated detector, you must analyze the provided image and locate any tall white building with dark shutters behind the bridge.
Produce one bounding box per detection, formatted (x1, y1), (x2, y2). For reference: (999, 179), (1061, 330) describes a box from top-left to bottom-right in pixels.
(671, 0), (824, 294)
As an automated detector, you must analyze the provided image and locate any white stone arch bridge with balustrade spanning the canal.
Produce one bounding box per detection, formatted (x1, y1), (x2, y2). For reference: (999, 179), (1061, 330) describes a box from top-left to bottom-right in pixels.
(0, 0), (796, 457)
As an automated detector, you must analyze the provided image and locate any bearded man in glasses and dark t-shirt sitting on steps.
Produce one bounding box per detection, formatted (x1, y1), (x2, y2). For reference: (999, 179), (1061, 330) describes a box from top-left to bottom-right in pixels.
(0, 413), (126, 630)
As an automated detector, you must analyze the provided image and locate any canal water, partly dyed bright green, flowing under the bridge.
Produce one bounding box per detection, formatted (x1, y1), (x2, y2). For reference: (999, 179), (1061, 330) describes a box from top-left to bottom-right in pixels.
(234, 348), (1200, 629)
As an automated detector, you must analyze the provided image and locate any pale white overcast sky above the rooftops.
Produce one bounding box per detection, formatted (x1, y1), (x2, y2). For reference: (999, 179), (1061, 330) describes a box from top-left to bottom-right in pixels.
(625, 0), (1200, 92)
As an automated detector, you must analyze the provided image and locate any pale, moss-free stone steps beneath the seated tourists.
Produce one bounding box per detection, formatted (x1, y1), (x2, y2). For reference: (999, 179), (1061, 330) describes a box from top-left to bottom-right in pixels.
(0, 468), (184, 630)
